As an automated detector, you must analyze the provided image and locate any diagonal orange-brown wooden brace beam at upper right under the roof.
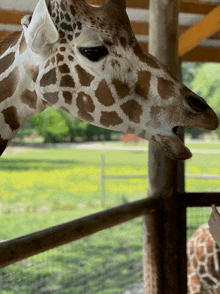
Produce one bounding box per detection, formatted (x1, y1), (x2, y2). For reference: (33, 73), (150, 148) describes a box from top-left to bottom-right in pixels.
(179, 5), (220, 57)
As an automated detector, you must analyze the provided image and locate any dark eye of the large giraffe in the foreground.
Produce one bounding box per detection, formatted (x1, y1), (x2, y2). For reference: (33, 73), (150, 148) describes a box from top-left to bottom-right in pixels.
(79, 46), (108, 62)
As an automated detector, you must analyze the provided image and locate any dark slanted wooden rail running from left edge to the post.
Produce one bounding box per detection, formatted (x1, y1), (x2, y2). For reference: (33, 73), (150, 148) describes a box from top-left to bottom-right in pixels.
(0, 195), (163, 268)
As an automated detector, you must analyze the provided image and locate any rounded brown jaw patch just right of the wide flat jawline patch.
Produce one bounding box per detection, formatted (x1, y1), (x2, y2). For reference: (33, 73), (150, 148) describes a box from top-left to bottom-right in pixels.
(121, 100), (143, 123)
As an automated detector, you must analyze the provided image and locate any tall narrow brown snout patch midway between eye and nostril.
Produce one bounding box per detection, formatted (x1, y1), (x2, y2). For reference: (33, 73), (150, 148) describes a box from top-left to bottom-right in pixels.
(135, 71), (151, 99)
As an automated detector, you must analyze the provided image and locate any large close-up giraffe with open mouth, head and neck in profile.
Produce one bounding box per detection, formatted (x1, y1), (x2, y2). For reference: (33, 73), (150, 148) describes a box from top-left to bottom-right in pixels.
(0, 0), (218, 160)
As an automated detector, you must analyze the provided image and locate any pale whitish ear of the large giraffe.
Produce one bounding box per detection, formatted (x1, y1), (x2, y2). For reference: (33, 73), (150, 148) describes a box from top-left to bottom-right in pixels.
(24, 0), (59, 56)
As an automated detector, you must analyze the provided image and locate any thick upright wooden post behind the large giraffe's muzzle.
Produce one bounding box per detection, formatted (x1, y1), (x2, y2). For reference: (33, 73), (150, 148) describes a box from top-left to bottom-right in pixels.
(143, 0), (187, 294)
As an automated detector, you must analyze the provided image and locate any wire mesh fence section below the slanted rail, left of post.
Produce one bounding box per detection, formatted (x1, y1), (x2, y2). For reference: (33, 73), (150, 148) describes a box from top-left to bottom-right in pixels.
(0, 218), (143, 294)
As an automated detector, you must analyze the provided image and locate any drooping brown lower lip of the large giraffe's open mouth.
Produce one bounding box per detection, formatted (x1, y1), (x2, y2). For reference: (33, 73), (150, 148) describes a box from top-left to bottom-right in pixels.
(154, 134), (192, 160)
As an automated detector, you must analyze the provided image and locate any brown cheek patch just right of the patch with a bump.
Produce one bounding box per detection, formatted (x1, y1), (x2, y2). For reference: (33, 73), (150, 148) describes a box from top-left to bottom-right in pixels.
(95, 80), (115, 106)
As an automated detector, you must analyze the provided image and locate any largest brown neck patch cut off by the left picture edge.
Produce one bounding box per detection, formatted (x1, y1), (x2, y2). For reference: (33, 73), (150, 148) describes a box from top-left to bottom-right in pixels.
(0, 67), (18, 102)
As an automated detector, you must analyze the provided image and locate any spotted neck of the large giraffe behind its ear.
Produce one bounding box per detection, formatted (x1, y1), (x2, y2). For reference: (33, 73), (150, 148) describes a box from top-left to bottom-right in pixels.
(0, 32), (45, 155)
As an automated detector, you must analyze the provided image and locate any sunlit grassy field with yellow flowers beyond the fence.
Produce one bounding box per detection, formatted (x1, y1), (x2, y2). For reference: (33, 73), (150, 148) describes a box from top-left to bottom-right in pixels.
(0, 143), (220, 294)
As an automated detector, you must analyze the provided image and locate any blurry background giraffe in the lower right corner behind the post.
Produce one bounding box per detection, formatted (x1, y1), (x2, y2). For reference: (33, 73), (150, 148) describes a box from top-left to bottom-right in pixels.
(187, 224), (220, 294)
